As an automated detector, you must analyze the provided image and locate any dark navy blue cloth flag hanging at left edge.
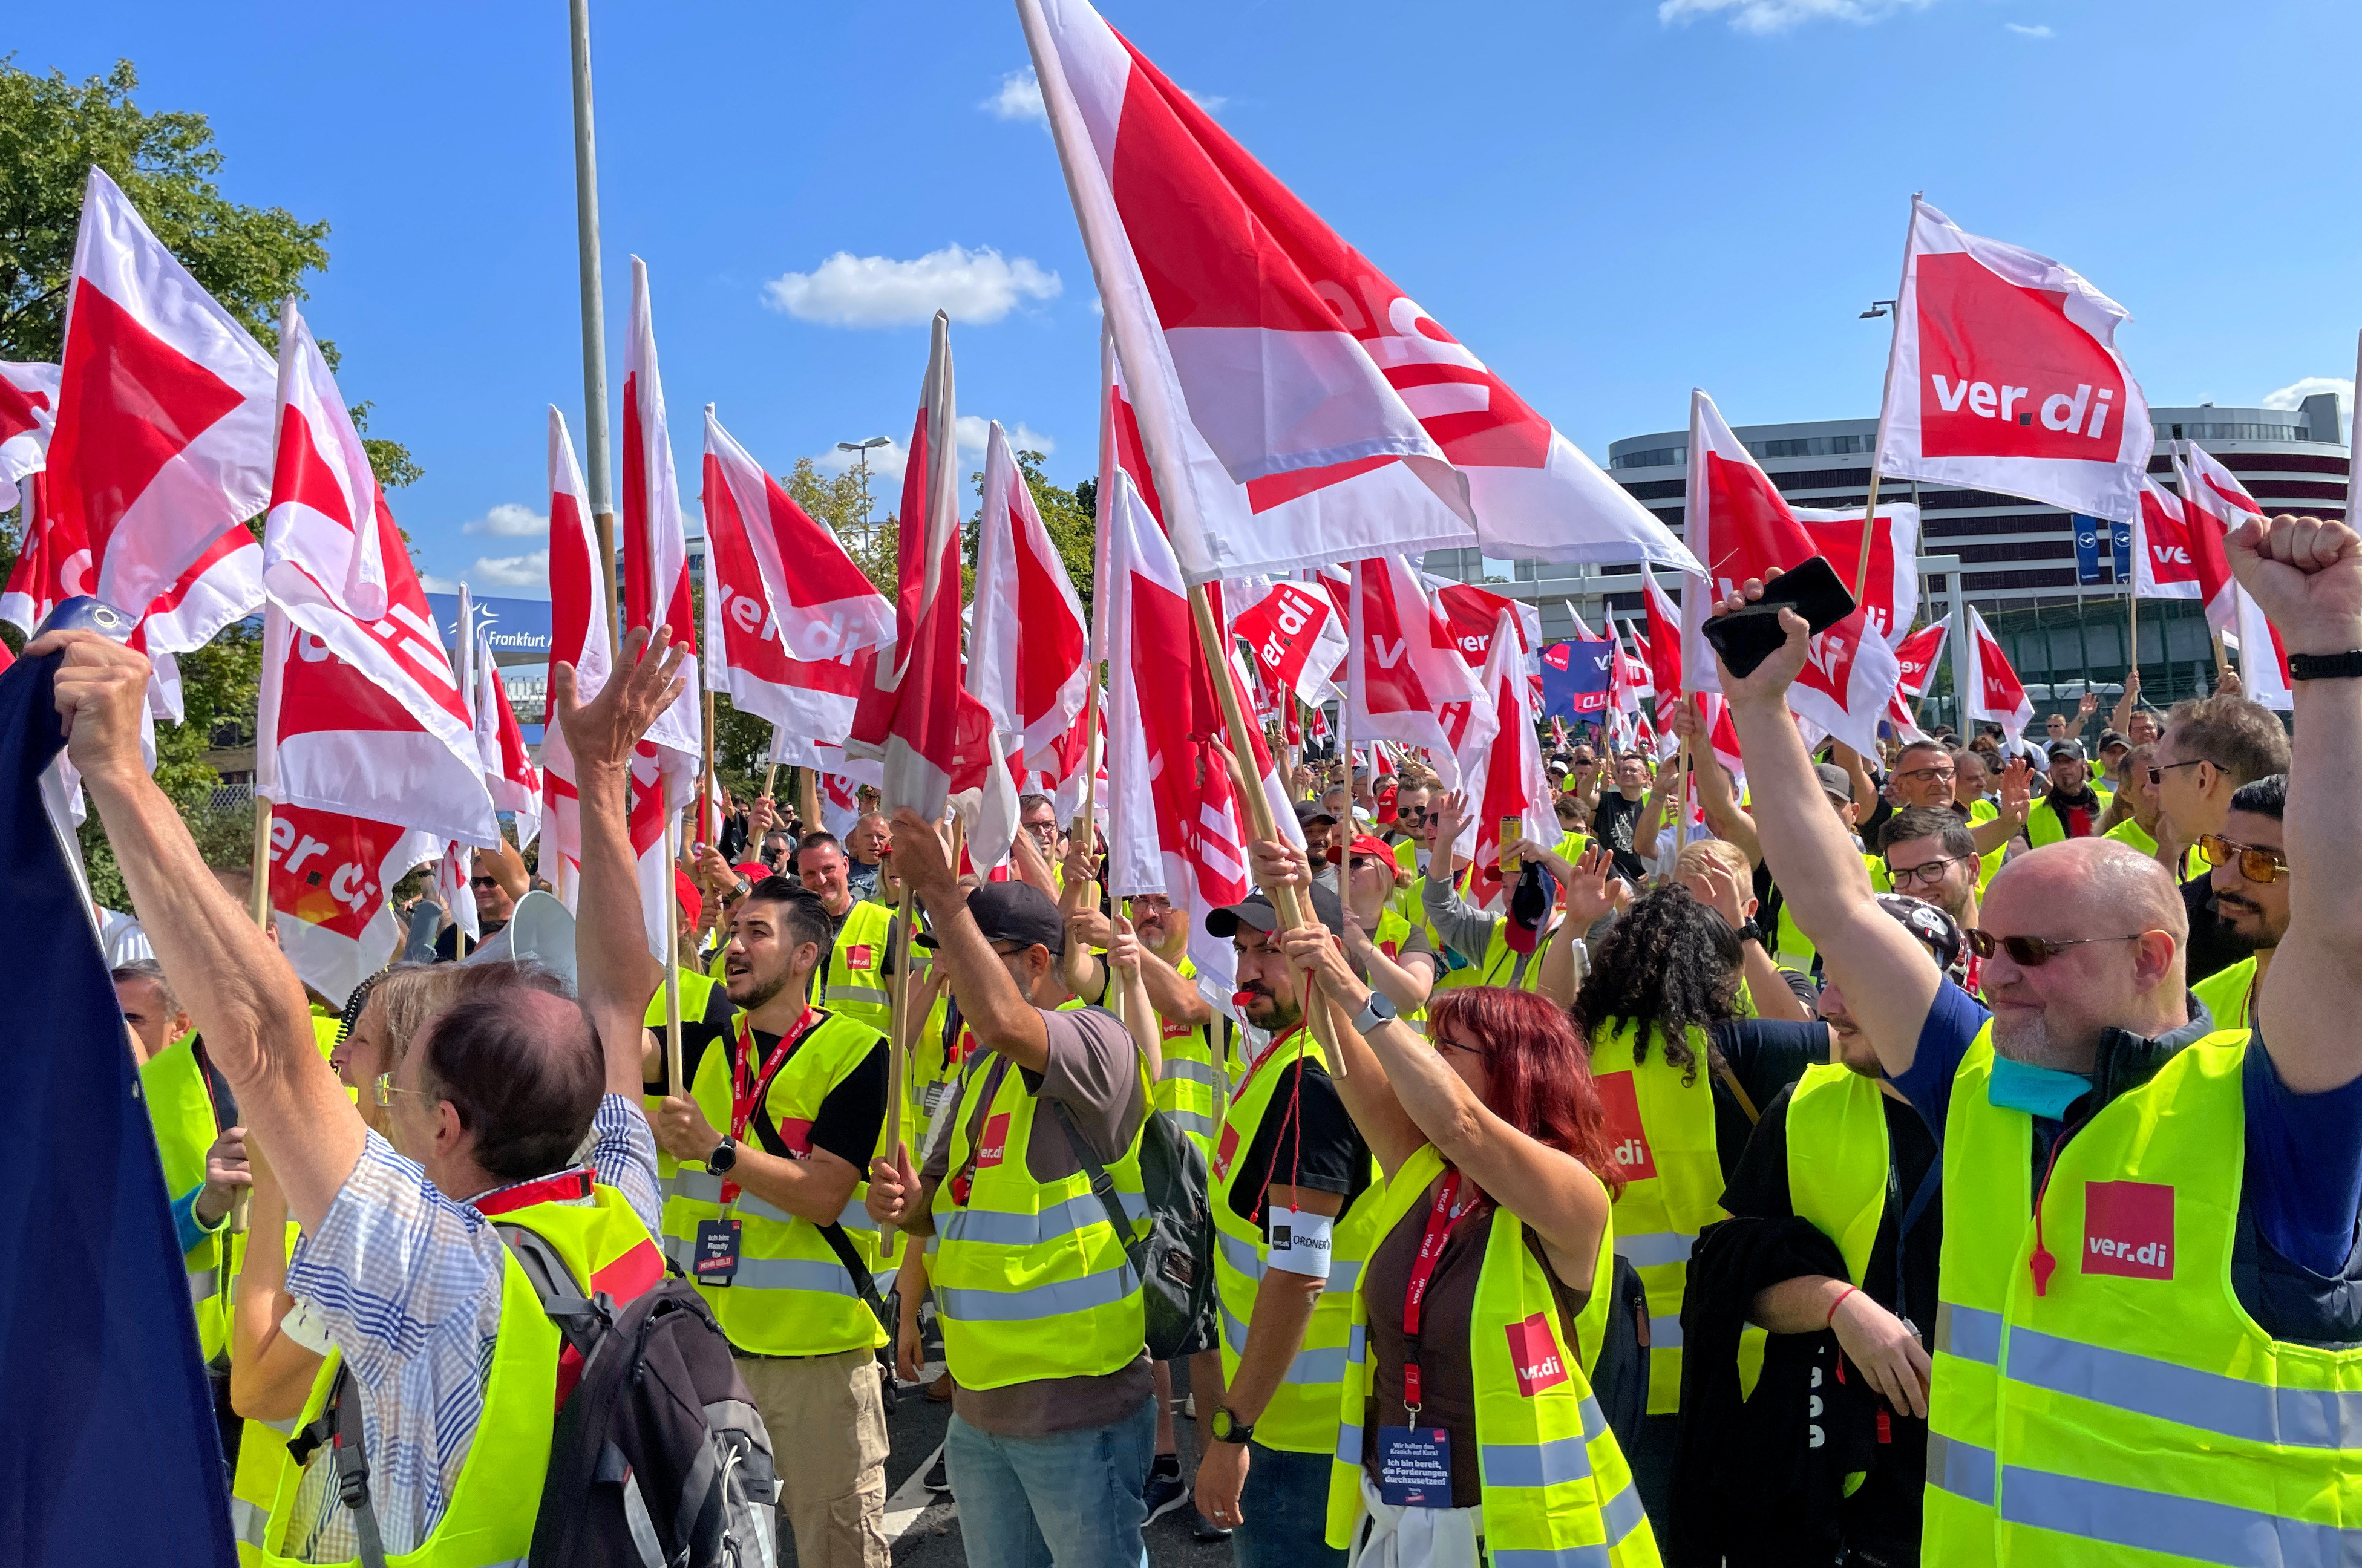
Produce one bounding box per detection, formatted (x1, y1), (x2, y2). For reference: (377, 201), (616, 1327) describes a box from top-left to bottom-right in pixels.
(0, 656), (236, 1568)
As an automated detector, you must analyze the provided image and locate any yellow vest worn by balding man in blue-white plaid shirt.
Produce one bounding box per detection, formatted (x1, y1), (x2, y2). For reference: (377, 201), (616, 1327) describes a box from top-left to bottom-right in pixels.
(241, 1186), (664, 1568)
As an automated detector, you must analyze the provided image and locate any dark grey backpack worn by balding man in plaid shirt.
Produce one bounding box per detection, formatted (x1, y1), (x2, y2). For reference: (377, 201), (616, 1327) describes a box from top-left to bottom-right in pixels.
(501, 1226), (779, 1568)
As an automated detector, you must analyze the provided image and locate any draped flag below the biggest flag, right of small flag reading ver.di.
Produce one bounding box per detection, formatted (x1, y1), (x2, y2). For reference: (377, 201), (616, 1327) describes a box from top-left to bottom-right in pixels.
(1346, 555), (1493, 789)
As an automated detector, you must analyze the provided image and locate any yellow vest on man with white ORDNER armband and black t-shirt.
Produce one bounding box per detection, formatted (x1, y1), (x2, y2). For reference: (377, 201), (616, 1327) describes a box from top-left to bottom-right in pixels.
(1209, 1030), (1379, 1455)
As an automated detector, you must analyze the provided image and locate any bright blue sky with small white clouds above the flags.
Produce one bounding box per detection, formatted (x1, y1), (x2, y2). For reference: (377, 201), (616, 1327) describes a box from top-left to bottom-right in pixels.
(10, 0), (2362, 595)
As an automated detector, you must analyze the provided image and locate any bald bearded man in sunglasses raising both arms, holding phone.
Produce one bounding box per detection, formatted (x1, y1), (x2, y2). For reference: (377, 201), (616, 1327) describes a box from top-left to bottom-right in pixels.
(1719, 517), (2362, 1566)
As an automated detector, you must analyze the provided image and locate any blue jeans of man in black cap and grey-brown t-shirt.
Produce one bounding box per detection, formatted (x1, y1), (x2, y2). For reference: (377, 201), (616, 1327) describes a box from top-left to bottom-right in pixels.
(943, 1398), (1157, 1568)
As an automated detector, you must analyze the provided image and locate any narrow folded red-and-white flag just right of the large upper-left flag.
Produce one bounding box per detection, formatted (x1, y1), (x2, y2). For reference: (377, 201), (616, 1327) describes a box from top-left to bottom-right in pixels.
(262, 298), (402, 635)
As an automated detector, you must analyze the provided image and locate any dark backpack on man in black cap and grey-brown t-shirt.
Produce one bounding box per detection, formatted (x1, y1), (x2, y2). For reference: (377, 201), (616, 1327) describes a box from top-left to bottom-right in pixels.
(1051, 1100), (1217, 1360)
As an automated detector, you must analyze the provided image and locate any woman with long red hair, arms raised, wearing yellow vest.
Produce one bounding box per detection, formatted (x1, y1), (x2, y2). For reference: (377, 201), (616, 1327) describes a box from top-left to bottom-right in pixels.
(1257, 845), (1658, 1568)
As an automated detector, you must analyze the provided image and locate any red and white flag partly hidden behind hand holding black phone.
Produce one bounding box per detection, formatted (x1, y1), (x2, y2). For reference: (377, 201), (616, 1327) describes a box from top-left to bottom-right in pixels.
(1658, 392), (1902, 756)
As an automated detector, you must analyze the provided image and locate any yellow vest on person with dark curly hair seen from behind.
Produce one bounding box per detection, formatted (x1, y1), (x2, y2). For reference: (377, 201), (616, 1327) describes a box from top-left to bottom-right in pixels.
(1592, 1020), (1724, 1414)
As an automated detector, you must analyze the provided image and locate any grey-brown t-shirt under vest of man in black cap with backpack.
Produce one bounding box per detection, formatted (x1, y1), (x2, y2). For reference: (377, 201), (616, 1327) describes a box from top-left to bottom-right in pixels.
(919, 1006), (1155, 1438)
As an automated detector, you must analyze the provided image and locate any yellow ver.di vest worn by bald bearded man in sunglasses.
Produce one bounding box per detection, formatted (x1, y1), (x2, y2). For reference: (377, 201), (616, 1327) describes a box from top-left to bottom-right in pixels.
(1923, 1025), (2362, 1566)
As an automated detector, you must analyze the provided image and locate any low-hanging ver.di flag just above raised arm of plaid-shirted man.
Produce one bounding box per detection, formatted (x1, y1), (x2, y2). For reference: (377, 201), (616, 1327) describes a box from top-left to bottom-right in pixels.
(269, 805), (442, 1006)
